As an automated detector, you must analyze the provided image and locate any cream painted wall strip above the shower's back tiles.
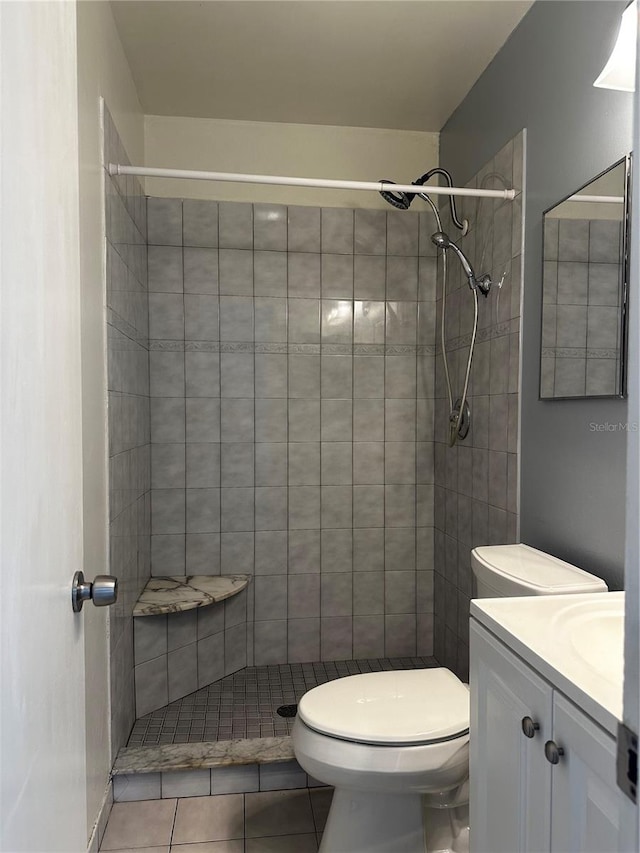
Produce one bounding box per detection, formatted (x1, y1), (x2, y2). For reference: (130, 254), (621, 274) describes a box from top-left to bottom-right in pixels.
(145, 115), (439, 208)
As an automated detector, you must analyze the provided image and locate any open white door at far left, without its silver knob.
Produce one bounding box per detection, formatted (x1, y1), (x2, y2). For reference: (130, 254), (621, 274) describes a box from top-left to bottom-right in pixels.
(0, 2), (87, 853)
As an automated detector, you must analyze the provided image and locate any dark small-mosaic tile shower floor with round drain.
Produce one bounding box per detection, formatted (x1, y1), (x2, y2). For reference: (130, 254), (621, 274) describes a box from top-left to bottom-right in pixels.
(132, 657), (438, 744)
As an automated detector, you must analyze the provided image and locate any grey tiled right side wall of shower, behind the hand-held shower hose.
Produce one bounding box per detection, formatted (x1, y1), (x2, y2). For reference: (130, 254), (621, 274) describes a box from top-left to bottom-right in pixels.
(434, 131), (525, 680)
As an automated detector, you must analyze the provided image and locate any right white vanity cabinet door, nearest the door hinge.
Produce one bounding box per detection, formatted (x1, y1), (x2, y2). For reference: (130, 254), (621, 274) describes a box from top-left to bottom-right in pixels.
(551, 693), (634, 853)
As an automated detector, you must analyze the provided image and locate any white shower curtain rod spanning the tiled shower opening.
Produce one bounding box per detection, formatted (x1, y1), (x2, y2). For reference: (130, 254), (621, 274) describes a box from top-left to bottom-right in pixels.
(109, 163), (517, 201)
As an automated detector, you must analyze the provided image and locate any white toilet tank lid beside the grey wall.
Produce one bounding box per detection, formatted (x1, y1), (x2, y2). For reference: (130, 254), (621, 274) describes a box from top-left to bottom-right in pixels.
(471, 543), (608, 595)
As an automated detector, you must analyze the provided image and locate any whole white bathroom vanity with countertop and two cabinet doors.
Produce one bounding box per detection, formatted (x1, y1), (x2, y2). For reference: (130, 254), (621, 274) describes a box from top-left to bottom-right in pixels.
(470, 593), (634, 853)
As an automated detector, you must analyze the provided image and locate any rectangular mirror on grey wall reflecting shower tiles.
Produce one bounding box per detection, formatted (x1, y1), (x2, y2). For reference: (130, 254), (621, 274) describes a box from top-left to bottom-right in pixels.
(540, 157), (631, 400)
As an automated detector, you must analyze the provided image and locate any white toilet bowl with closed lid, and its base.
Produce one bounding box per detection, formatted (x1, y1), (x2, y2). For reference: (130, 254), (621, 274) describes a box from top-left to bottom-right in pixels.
(292, 668), (469, 853)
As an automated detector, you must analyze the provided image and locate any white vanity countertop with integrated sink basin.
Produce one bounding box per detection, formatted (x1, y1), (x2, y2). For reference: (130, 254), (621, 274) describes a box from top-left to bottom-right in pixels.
(471, 592), (624, 736)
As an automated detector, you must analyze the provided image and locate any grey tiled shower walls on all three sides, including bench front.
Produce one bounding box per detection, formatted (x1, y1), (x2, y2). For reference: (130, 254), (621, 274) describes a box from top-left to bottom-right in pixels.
(106, 105), (522, 745)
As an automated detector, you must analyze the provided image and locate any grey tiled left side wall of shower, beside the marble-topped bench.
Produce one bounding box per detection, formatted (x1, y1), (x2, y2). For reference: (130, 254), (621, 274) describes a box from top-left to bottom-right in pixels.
(103, 107), (151, 754)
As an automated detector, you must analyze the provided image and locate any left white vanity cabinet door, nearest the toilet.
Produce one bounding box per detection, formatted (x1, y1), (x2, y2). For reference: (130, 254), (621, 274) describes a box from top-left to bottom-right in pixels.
(469, 620), (552, 853)
